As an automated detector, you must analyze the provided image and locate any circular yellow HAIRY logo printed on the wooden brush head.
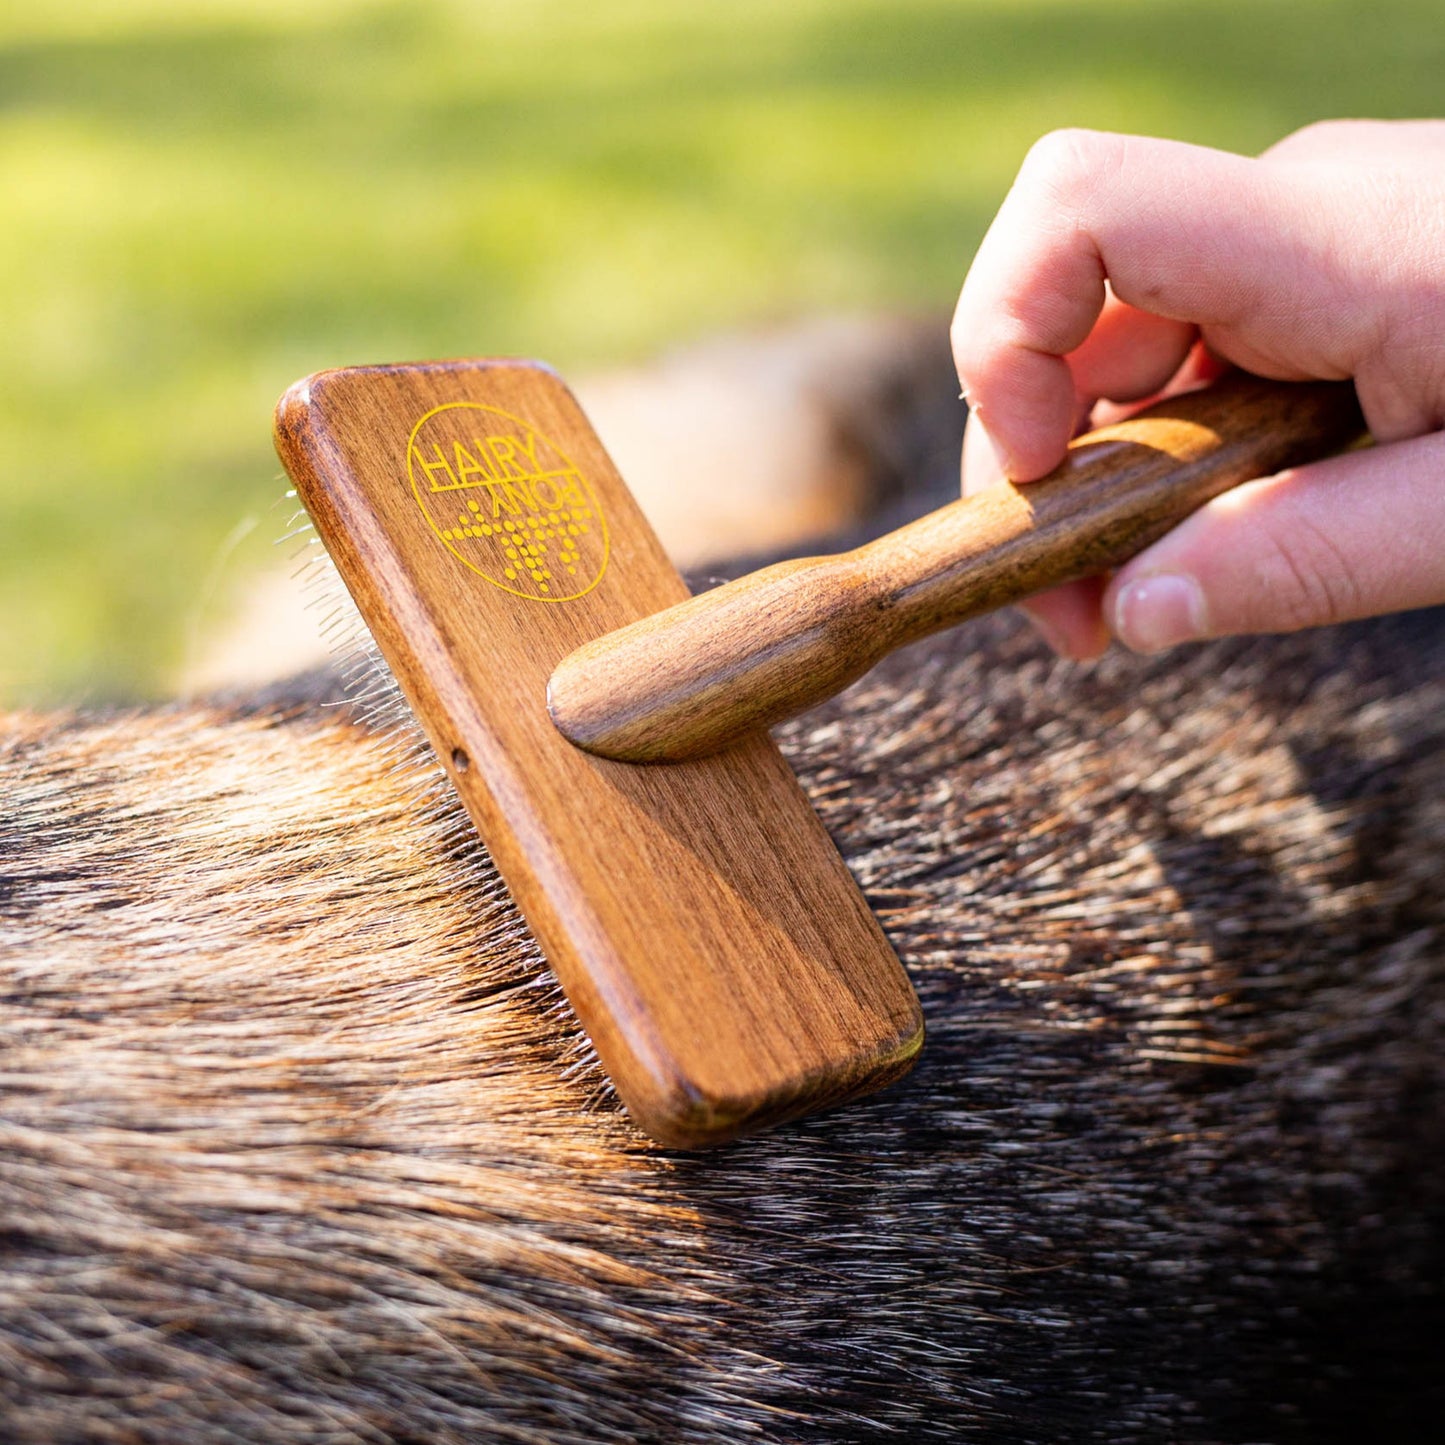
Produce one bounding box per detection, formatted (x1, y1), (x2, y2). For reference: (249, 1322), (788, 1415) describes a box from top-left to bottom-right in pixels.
(406, 402), (608, 603)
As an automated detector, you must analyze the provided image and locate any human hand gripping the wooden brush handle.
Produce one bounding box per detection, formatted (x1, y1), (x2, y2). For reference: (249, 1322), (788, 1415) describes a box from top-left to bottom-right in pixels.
(954, 121), (1445, 657)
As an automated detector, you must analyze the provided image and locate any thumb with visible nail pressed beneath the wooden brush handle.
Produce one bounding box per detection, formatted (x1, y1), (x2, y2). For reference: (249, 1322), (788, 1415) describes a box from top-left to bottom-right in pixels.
(1104, 432), (1445, 652)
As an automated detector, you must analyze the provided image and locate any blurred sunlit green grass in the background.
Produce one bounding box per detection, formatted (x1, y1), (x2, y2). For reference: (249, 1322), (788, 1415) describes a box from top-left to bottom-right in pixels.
(0, 0), (1445, 704)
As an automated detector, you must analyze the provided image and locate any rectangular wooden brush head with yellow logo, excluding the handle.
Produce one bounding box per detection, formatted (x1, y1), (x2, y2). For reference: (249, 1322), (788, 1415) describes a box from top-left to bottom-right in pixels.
(276, 361), (922, 1147)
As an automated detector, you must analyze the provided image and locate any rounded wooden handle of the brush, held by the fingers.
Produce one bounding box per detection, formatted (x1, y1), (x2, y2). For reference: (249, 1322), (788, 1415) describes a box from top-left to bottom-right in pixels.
(548, 373), (1364, 763)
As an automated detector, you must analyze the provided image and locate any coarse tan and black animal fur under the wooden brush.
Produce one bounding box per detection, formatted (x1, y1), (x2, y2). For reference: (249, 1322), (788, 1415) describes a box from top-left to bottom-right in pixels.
(0, 592), (1445, 1445)
